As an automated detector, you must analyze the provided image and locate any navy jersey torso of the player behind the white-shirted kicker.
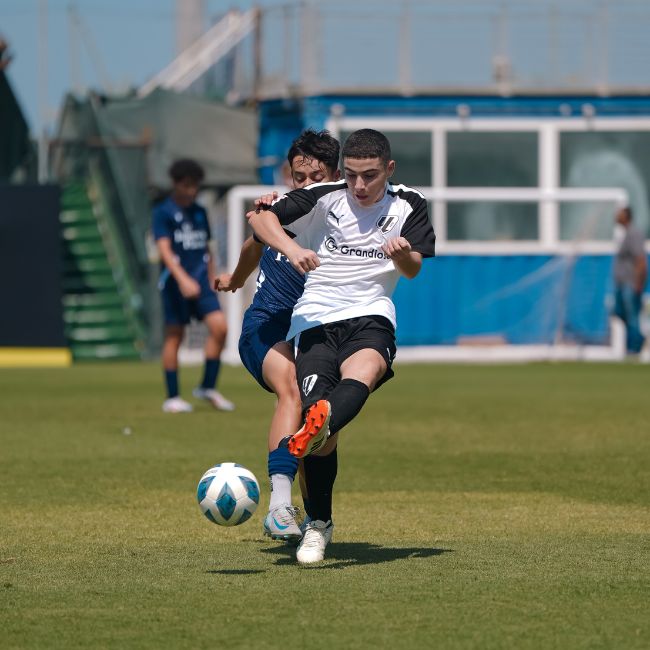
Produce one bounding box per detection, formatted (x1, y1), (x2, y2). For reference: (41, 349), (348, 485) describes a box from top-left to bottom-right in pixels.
(251, 246), (305, 314)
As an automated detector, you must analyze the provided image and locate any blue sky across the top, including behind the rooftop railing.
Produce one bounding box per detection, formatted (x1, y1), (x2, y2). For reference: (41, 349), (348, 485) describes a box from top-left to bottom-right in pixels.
(0, 0), (650, 135)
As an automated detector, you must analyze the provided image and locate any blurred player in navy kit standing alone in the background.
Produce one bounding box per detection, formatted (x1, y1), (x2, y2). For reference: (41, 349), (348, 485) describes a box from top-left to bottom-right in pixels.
(153, 159), (235, 413)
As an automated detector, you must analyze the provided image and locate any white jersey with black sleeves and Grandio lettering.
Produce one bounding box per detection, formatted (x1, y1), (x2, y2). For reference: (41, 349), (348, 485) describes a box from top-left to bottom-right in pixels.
(270, 181), (435, 340)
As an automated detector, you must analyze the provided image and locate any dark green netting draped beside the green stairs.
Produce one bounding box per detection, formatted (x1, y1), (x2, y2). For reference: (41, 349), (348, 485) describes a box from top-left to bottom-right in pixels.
(51, 90), (257, 352)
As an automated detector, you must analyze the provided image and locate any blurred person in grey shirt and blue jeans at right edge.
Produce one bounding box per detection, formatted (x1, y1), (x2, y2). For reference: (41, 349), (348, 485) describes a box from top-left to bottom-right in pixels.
(614, 207), (648, 354)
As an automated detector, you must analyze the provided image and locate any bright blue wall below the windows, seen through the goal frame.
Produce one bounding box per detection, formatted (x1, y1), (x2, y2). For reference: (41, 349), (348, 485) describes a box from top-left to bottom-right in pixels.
(393, 255), (612, 345)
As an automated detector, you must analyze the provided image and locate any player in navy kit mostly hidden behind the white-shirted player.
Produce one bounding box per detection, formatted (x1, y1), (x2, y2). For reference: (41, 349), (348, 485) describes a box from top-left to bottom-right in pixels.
(217, 129), (340, 541)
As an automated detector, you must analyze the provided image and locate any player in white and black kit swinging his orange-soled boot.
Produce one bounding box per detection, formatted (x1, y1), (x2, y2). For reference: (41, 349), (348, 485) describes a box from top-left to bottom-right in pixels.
(247, 129), (435, 564)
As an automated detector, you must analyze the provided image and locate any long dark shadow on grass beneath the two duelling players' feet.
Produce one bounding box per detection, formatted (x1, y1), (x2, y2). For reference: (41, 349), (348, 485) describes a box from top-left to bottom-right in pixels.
(261, 542), (454, 569)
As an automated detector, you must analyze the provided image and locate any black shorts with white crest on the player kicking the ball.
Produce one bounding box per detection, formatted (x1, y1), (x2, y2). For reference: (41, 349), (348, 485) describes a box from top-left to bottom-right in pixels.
(296, 316), (396, 408)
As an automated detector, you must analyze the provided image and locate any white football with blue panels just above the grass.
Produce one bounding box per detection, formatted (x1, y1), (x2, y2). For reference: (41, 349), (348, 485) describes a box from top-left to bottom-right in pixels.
(196, 463), (260, 526)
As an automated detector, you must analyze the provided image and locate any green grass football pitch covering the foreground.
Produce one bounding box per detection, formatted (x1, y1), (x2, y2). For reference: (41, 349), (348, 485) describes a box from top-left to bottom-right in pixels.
(0, 364), (650, 650)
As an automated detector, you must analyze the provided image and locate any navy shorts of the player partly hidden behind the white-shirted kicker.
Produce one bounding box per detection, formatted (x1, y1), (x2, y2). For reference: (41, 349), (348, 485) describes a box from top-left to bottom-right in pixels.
(239, 309), (292, 393)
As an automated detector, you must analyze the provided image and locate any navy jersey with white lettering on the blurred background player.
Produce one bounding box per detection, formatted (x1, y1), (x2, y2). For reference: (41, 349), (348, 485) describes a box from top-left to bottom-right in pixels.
(153, 197), (211, 278)
